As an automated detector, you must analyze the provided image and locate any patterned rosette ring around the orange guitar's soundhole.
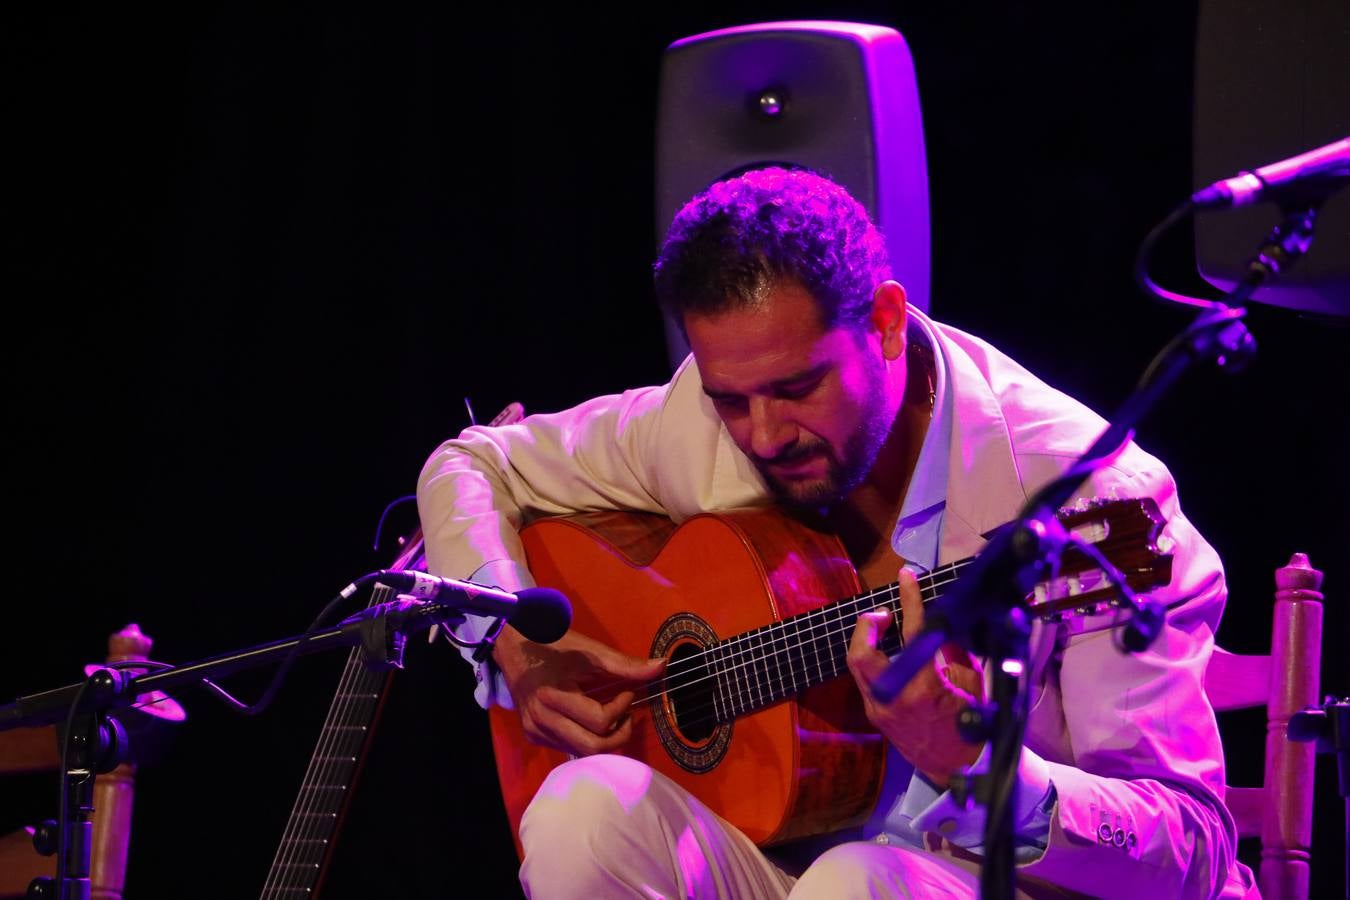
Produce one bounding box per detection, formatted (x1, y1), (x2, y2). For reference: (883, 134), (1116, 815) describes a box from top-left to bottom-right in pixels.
(651, 613), (732, 773)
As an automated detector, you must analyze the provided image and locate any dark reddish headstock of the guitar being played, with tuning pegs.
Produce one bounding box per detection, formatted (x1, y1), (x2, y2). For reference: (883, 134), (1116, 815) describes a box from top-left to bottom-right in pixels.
(1029, 497), (1172, 619)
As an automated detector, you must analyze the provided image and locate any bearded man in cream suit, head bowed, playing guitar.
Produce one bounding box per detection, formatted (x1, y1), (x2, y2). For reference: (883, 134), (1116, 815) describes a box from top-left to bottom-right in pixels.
(419, 169), (1251, 899)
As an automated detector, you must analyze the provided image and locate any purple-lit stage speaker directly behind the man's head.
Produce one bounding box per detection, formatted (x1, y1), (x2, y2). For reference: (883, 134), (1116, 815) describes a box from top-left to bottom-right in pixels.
(656, 22), (930, 366)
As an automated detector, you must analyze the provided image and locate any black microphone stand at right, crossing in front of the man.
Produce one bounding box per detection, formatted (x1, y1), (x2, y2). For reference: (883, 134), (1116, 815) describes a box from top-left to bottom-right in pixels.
(873, 200), (1320, 900)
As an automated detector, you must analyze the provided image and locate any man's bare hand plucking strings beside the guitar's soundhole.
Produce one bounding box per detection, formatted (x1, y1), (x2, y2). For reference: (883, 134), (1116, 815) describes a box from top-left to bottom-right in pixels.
(493, 626), (666, 756)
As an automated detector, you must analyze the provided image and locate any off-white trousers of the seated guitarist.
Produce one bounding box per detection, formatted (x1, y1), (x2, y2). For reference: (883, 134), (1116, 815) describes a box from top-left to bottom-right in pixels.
(520, 756), (1040, 900)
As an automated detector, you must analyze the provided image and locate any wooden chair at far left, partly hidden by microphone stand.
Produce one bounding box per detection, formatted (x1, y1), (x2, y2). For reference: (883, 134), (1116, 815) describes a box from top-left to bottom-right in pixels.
(0, 625), (182, 900)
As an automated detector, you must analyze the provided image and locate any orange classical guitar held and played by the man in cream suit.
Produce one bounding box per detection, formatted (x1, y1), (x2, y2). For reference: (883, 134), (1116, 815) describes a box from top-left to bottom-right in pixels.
(490, 499), (1172, 850)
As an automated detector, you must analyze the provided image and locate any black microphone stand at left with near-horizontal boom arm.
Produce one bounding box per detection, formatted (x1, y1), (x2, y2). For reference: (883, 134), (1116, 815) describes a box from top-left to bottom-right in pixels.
(0, 582), (475, 900)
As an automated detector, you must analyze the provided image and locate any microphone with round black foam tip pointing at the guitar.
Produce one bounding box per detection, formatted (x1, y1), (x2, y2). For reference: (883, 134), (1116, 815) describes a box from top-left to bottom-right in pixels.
(360, 569), (572, 644)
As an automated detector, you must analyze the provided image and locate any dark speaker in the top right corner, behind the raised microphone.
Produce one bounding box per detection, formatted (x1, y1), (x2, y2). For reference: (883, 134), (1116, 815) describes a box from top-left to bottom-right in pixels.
(1193, 0), (1350, 316)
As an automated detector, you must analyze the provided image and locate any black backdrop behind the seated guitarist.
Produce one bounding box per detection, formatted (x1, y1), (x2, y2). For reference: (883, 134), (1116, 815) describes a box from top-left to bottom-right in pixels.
(0, 1), (1350, 897)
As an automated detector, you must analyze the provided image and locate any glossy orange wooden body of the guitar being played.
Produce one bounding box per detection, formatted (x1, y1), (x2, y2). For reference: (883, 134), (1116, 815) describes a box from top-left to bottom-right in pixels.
(490, 509), (886, 850)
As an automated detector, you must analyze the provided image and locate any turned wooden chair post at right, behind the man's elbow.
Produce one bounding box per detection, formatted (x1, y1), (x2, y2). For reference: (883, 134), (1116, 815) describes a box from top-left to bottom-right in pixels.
(1204, 553), (1322, 900)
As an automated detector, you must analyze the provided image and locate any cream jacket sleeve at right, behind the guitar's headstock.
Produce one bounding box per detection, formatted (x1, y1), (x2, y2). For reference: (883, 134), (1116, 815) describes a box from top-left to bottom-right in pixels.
(1019, 449), (1245, 897)
